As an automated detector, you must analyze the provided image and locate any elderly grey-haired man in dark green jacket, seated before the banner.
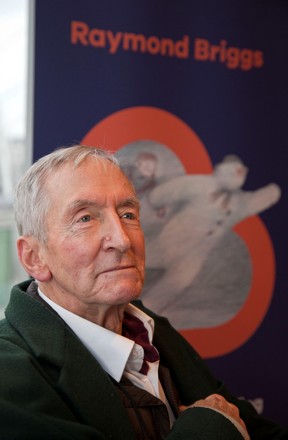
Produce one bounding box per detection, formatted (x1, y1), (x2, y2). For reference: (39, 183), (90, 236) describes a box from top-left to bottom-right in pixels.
(0, 146), (288, 440)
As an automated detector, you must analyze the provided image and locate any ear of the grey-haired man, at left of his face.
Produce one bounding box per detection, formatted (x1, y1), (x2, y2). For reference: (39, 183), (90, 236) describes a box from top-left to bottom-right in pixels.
(17, 236), (51, 282)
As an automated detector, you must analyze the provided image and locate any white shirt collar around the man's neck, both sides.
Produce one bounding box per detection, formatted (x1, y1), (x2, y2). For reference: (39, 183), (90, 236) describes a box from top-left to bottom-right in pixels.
(38, 288), (154, 382)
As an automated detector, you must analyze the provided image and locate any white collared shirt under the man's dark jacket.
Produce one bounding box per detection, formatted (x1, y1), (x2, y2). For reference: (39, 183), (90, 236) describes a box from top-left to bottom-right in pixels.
(38, 288), (175, 424)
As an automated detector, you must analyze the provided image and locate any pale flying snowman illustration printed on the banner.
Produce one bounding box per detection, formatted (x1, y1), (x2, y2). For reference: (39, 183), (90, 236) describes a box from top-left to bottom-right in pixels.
(140, 155), (281, 313)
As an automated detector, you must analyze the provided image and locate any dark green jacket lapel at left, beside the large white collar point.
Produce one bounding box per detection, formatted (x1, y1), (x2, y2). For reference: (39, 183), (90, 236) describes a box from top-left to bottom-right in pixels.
(6, 284), (135, 440)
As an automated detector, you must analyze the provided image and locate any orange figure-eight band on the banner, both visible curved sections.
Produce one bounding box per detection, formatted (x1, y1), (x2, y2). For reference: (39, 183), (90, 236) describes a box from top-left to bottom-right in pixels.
(82, 107), (275, 358)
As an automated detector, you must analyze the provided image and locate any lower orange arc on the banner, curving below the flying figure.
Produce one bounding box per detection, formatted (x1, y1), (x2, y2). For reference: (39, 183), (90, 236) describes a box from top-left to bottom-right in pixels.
(181, 216), (275, 358)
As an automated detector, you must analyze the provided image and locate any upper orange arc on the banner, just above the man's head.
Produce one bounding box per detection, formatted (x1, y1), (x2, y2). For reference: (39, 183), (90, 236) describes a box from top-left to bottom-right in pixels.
(82, 107), (212, 174)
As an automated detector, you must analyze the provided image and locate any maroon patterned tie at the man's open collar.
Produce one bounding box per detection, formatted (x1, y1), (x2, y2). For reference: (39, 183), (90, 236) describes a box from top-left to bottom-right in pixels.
(122, 312), (159, 374)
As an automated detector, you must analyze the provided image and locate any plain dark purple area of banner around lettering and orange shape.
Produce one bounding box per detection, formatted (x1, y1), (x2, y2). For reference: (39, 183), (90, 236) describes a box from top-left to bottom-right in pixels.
(33, 0), (288, 424)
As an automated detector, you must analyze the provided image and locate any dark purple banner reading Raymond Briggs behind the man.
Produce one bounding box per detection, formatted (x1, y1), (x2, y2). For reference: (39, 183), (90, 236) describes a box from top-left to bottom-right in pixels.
(33, 0), (288, 424)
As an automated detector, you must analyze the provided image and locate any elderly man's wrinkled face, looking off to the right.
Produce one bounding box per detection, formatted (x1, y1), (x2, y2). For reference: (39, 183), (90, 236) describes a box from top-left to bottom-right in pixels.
(40, 157), (145, 315)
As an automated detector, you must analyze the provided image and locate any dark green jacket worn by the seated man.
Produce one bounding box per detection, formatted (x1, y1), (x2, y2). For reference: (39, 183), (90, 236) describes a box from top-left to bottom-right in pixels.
(0, 281), (288, 440)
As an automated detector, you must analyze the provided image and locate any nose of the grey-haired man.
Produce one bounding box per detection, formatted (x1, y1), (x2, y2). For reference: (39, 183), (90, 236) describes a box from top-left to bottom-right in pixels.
(102, 214), (131, 252)
